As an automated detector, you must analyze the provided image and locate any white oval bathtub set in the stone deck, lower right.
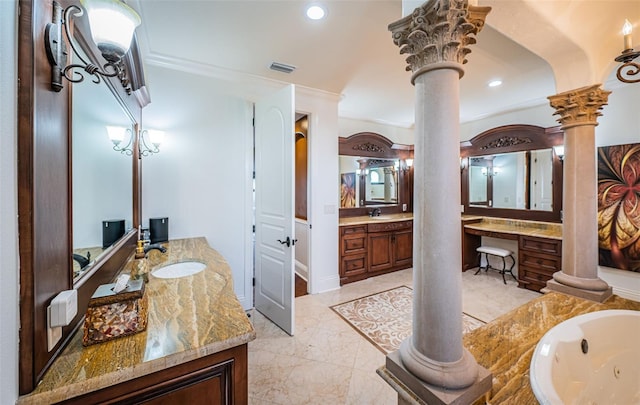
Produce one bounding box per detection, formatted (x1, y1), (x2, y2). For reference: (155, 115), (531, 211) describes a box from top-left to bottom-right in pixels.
(529, 310), (640, 405)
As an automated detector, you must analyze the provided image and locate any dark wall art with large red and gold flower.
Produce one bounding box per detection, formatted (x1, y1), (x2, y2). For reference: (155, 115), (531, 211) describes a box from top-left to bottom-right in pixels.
(598, 143), (640, 272)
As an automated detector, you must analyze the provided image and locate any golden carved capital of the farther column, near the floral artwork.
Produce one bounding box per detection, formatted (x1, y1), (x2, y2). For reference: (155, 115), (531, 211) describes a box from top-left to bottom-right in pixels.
(548, 84), (611, 129)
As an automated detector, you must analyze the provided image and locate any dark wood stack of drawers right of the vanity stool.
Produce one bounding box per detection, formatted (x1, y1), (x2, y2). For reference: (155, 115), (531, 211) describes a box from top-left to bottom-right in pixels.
(518, 235), (562, 292)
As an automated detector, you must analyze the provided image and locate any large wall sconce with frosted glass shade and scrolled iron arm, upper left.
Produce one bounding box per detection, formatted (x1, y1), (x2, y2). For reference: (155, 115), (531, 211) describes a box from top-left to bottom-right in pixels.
(44, 0), (141, 93)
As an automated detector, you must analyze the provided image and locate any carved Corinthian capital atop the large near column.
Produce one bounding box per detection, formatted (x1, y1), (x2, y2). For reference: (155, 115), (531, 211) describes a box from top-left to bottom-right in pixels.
(389, 0), (491, 83)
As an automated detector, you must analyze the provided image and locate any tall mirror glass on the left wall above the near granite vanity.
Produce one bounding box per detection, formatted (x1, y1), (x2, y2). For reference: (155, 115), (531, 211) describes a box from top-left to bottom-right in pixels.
(71, 46), (135, 283)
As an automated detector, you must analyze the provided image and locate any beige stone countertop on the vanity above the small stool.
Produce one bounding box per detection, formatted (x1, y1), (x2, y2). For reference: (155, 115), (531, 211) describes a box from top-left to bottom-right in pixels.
(463, 217), (562, 240)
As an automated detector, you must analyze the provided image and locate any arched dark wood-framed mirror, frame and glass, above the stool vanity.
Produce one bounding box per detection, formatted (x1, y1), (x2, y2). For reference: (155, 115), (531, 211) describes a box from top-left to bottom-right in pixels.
(460, 125), (563, 222)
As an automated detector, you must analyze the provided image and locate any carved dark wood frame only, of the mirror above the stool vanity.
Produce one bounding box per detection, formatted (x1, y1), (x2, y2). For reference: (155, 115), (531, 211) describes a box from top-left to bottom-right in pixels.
(460, 125), (564, 222)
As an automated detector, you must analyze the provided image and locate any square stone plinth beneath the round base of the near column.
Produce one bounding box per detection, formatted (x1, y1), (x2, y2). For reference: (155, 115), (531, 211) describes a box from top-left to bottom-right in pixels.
(377, 351), (492, 405)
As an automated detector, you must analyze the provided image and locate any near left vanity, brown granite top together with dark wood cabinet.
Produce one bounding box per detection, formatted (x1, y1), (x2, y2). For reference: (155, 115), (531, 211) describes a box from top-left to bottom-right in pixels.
(17, 238), (256, 405)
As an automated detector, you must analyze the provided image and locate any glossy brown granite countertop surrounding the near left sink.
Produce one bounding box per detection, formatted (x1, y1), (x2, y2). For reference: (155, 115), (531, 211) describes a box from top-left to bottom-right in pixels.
(17, 238), (256, 404)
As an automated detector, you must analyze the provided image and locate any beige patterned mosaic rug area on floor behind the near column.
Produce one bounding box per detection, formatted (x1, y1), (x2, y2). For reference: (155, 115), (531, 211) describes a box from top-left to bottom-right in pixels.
(331, 286), (485, 354)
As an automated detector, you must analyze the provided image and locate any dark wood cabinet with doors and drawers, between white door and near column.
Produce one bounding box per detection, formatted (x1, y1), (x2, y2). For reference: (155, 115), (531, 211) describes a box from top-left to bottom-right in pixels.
(340, 221), (413, 284)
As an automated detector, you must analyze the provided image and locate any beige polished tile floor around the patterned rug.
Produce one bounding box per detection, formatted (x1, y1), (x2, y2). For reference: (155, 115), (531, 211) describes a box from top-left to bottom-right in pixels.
(249, 269), (540, 405)
